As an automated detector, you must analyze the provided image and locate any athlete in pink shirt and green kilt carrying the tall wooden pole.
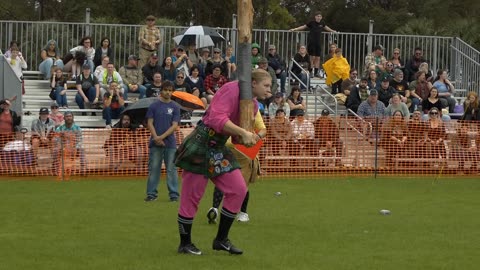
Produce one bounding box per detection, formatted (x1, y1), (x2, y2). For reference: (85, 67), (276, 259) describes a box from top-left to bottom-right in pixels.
(176, 70), (272, 255)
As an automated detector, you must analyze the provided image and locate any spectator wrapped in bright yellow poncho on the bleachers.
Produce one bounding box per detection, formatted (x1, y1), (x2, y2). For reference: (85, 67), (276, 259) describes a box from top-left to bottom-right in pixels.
(323, 48), (350, 95)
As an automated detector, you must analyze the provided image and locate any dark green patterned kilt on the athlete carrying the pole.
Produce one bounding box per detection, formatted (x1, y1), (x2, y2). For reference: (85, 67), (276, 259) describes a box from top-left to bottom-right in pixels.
(175, 122), (240, 178)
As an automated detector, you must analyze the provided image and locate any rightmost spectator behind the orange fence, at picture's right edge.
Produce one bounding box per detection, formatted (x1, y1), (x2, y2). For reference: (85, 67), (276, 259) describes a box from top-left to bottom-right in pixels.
(451, 122), (480, 174)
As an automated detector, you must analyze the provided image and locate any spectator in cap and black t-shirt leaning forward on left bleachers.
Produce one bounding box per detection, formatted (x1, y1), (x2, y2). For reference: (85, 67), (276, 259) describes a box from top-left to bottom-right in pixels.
(75, 64), (100, 112)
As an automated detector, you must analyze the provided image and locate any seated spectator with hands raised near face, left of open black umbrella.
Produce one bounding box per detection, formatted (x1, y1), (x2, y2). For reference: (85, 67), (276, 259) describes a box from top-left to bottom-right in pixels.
(103, 82), (125, 127)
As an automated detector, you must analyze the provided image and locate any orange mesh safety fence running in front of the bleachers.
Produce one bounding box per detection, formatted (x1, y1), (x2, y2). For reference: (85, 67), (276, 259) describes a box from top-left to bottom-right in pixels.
(0, 116), (480, 179)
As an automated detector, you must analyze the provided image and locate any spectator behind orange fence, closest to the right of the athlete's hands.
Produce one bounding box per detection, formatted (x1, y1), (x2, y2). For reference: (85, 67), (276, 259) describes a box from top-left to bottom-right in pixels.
(266, 109), (293, 156)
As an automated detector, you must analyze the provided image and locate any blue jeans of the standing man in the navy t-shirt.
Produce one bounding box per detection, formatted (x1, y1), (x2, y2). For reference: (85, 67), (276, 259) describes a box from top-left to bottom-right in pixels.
(147, 146), (180, 199)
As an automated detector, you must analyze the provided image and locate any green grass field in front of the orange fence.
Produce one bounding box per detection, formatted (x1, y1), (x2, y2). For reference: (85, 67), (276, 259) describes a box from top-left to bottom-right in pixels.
(0, 177), (480, 270)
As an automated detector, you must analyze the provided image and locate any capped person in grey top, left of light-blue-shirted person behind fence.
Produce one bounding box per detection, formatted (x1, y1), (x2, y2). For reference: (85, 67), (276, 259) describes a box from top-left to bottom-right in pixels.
(30, 107), (55, 156)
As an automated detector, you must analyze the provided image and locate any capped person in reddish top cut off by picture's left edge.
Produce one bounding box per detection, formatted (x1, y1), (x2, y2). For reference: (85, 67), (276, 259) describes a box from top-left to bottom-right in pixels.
(0, 99), (21, 147)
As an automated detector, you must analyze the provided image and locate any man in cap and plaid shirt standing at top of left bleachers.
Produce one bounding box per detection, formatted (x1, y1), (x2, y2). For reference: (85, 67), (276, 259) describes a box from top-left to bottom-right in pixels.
(138, 15), (162, 67)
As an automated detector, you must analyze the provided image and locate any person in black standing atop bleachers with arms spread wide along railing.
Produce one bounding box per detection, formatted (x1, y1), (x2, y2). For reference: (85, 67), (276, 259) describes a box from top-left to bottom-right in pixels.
(290, 11), (335, 76)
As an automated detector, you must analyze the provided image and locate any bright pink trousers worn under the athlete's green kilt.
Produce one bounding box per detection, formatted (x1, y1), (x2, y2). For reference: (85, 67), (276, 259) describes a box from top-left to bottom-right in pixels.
(178, 169), (247, 218)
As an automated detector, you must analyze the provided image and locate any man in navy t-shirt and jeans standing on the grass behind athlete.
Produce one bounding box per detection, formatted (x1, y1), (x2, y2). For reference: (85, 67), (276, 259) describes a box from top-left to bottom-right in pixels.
(145, 81), (180, 202)
